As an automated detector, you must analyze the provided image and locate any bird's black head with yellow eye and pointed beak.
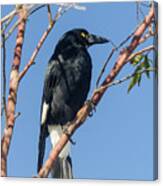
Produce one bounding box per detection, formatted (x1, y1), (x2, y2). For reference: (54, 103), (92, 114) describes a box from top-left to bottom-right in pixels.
(59, 28), (109, 47)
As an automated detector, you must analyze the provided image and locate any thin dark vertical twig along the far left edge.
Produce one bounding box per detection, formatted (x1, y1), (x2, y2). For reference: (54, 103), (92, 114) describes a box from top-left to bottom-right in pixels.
(2, 33), (7, 125)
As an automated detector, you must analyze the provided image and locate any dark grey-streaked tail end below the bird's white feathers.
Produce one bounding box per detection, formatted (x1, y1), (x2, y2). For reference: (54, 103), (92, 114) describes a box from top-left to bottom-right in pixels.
(51, 156), (73, 179)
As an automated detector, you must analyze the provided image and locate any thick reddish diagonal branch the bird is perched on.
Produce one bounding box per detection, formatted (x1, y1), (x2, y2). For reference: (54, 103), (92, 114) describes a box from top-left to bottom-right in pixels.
(38, 2), (154, 177)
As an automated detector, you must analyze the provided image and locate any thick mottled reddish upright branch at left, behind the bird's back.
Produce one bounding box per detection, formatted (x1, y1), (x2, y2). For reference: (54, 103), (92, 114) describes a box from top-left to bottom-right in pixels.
(1, 7), (27, 176)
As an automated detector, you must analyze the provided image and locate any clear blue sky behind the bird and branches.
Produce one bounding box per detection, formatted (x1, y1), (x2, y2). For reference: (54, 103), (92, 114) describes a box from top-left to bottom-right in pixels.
(2, 3), (157, 180)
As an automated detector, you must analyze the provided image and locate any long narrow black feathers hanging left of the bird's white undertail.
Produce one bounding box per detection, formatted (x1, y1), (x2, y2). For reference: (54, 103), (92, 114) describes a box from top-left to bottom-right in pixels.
(37, 124), (48, 172)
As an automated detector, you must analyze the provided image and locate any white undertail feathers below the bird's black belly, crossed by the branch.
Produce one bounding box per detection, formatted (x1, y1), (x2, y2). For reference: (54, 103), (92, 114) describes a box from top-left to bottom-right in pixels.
(48, 125), (70, 158)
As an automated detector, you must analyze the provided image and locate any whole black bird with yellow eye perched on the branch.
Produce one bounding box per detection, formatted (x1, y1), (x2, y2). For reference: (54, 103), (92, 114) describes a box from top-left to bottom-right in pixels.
(37, 29), (108, 178)
